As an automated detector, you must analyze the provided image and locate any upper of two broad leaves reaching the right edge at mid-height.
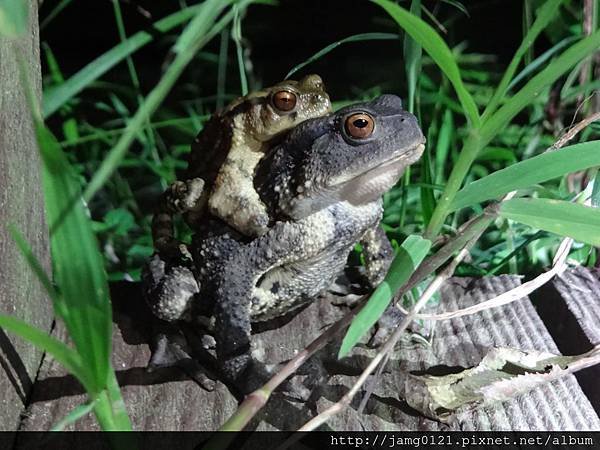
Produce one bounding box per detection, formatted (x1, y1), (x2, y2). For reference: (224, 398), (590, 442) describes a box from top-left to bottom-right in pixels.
(451, 141), (600, 211)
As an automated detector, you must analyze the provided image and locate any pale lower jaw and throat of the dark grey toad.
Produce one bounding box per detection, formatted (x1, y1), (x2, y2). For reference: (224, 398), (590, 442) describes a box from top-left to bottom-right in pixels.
(332, 143), (425, 205)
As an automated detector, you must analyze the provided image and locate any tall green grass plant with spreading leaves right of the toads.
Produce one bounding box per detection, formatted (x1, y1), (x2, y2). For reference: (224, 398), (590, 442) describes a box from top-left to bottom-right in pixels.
(343, 0), (600, 351)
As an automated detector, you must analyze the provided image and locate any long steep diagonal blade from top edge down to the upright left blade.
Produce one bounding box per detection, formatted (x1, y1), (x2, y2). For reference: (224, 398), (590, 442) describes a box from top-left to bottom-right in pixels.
(83, 0), (243, 201)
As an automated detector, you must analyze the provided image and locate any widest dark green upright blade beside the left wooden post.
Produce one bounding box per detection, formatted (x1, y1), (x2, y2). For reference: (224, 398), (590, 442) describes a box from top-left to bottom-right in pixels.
(36, 122), (112, 391)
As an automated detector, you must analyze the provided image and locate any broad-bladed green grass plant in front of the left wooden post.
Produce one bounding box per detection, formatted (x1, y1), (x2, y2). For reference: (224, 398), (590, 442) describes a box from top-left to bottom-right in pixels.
(5, 120), (131, 430)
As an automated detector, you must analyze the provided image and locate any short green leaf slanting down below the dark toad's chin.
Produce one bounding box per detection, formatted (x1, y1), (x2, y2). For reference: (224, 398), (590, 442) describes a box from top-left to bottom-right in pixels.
(338, 235), (431, 358)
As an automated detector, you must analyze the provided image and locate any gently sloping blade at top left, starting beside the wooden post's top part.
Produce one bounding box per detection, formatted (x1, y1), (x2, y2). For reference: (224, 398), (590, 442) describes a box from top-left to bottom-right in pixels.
(42, 4), (203, 118)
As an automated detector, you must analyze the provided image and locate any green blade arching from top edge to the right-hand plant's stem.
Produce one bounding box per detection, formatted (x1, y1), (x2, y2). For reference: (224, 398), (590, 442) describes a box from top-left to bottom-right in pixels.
(372, 0), (480, 127)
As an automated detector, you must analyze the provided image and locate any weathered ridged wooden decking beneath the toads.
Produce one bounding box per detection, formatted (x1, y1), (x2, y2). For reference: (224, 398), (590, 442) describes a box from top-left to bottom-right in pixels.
(22, 276), (600, 430)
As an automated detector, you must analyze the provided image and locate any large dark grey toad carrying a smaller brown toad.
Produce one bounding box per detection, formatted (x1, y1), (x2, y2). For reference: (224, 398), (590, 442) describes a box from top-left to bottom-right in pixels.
(145, 95), (425, 392)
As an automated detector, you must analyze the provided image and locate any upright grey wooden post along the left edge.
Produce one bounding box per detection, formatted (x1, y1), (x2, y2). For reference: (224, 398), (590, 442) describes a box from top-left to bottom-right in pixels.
(0, 0), (52, 436)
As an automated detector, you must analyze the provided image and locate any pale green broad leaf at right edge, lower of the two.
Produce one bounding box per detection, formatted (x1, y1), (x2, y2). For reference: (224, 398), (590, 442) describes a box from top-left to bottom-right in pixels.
(500, 198), (600, 246)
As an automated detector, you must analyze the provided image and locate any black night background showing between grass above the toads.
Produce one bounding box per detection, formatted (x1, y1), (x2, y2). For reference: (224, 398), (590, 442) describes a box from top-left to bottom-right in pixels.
(41, 0), (528, 98)
